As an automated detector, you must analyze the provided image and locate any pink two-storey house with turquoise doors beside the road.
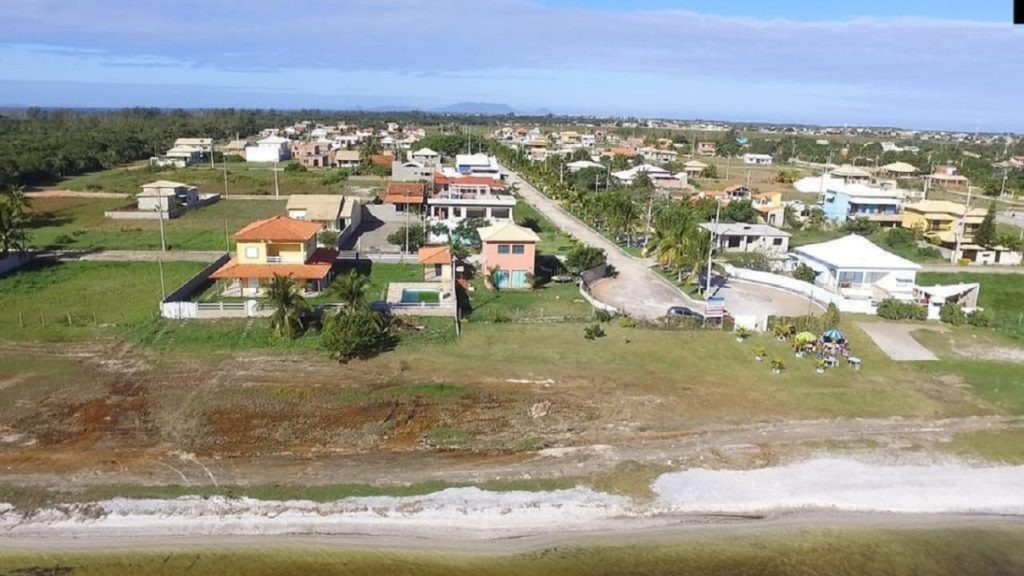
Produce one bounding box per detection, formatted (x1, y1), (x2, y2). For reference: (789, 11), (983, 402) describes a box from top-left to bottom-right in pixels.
(477, 221), (541, 289)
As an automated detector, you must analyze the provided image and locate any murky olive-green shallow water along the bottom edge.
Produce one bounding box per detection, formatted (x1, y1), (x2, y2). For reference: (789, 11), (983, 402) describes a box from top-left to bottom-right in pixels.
(0, 520), (1024, 576)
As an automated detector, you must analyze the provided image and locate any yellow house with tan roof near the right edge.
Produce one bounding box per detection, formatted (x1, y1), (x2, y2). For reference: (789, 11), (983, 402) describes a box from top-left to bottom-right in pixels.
(902, 200), (1022, 265)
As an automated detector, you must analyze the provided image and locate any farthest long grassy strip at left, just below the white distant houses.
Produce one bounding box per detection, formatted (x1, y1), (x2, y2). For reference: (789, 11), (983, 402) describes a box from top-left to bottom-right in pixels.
(50, 163), (385, 195)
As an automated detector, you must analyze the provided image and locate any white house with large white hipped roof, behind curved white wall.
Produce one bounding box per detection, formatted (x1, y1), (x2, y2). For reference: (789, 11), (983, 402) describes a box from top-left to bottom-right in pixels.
(793, 234), (921, 303)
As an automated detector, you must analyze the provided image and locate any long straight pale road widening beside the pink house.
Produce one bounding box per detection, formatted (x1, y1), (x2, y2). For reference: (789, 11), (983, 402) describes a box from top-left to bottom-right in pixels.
(503, 167), (703, 319)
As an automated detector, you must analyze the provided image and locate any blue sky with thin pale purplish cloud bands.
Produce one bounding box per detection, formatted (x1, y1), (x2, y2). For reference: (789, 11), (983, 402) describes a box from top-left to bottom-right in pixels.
(0, 0), (1024, 132)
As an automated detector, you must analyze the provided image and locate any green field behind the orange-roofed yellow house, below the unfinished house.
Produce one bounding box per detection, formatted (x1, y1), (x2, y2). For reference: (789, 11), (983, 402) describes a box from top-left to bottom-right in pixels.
(29, 198), (285, 250)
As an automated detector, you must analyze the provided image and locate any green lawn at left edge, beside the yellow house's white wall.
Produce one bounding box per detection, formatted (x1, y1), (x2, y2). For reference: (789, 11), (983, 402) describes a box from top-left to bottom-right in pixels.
(0, 261), (204, 340)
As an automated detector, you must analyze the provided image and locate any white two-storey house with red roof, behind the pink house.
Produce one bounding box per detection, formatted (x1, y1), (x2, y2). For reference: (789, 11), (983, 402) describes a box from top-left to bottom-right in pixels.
(427, 174), (516, 230)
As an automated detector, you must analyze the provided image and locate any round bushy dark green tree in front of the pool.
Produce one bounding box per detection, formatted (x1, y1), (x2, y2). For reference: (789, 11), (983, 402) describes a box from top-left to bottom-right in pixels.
(321, 302), (396, 363)
